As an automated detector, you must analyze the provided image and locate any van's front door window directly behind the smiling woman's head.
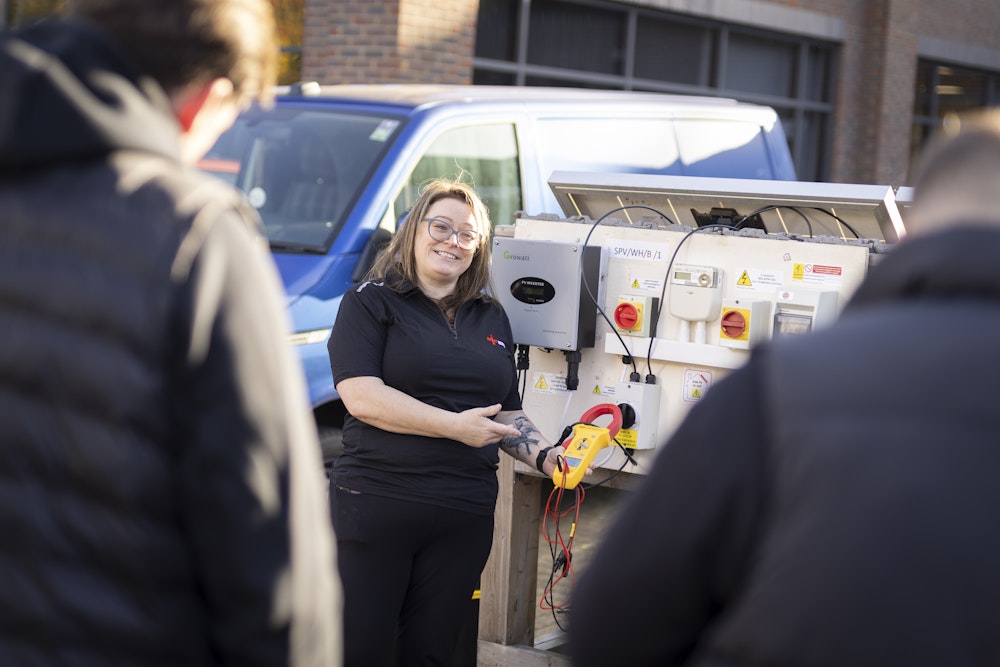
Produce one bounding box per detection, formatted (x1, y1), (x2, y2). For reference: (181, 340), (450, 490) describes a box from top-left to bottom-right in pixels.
(394, 123), (523, 230)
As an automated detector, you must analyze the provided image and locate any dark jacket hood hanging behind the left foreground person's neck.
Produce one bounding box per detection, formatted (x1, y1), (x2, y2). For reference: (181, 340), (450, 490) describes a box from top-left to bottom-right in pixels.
(0, 20), (180, 172)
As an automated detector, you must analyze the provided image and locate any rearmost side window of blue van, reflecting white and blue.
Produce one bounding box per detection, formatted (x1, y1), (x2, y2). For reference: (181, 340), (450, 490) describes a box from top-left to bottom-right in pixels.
(674, 119), (774, 179)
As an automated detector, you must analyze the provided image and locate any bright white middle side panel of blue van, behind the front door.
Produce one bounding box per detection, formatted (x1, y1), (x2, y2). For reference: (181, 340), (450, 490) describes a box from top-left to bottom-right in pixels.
(538, 118), (682, 180)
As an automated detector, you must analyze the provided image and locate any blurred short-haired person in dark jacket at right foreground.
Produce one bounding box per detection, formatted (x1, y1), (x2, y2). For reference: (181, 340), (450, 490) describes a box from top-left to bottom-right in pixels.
(569, 112), (1000, 667)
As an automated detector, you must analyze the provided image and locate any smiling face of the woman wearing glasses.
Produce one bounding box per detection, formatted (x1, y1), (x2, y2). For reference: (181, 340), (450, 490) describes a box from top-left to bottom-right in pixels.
(414, 197), (478, 299)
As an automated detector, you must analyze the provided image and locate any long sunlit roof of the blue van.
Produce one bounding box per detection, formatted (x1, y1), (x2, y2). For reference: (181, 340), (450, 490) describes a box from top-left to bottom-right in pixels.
(275, 82), (757, 109)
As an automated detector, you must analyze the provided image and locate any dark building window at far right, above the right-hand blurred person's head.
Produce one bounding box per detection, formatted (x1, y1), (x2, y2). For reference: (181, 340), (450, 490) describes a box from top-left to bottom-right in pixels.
(910, 59), (1000, 177)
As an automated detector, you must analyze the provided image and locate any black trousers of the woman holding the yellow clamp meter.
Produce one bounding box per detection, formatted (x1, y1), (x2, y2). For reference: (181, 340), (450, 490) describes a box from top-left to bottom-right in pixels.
(330, 487), (493, 667)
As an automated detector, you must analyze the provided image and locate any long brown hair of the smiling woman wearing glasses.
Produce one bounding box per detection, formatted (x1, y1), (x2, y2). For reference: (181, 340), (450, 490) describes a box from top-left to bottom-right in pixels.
(367, 178), (491, 310)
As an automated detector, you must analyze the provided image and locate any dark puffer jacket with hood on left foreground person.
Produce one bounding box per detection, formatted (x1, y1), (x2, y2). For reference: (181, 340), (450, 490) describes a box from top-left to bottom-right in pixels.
(0, 15), (340, 667)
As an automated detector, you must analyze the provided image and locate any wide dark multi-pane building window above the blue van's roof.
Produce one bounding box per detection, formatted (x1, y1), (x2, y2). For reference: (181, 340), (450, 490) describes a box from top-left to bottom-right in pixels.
(473, 0), (837, 181)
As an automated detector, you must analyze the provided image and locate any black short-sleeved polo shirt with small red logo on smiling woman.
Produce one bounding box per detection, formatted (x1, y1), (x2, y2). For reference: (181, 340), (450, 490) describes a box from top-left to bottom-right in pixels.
(329, 282), (521, 514)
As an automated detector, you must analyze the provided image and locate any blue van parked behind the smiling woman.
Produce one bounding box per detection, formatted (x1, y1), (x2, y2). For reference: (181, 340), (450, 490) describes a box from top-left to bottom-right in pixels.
(200, 84), (795, 458)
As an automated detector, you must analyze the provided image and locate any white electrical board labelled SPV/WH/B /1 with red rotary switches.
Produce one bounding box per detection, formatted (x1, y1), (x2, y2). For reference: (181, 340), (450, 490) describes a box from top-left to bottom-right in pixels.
(495, 172), (902, 474)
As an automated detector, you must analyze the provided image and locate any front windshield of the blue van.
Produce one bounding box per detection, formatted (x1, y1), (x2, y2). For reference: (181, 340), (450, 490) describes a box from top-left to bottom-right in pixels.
(198, 107), (403, 252)
